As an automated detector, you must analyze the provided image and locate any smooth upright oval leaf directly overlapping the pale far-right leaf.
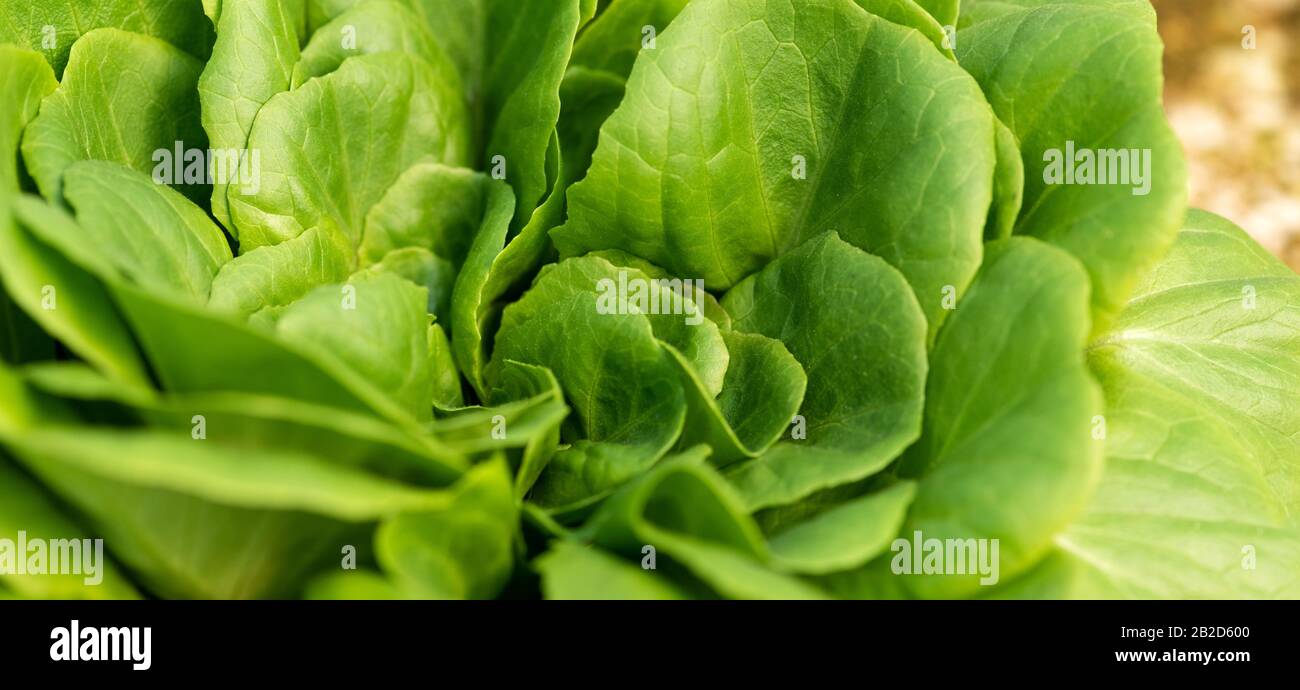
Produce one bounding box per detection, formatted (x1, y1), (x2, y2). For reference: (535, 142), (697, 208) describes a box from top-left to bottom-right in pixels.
(898, 238), (1102, 598)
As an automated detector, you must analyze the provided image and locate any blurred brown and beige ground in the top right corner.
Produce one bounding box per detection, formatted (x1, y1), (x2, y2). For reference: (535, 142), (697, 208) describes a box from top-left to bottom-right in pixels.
(1153, 0), (1300, 272)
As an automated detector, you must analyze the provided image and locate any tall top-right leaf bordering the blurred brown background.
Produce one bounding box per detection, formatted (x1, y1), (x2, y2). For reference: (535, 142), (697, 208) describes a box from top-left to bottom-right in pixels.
(958, 0), (1187, 333)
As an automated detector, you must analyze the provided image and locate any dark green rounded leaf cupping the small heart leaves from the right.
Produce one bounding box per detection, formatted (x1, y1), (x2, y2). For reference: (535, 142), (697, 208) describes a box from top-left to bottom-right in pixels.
(723, 233), (928, 509)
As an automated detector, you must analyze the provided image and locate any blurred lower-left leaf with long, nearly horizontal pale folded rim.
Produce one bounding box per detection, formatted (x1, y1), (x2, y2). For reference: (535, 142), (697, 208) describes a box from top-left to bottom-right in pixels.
(4, 428), (447, 599)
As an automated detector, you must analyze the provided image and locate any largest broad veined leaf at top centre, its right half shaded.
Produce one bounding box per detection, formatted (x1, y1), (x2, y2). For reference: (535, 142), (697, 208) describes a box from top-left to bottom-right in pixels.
(551, 0), (995, 337)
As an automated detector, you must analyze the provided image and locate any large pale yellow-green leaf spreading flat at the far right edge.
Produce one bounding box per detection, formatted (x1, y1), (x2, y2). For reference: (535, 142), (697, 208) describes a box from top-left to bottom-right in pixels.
(1004, 211), (1300, 599)
